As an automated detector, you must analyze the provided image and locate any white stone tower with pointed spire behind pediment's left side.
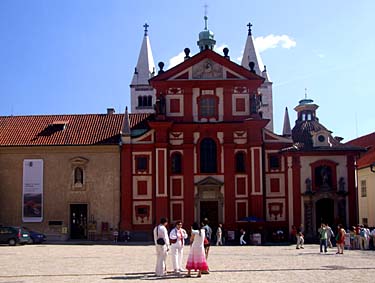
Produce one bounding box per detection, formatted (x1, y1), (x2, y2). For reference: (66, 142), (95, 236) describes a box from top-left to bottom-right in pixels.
(130, 23), (156, 113)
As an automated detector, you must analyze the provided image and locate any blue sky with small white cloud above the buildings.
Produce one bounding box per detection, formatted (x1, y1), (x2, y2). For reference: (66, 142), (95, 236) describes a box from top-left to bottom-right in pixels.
(0, 0), (375, 141)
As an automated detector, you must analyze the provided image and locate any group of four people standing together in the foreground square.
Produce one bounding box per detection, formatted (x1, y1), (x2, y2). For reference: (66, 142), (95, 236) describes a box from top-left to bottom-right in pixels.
(153, 217), (212, 277)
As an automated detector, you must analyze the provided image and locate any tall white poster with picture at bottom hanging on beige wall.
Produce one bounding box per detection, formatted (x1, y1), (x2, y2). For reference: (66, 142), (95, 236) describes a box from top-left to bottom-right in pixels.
(22, 159), (43, 222)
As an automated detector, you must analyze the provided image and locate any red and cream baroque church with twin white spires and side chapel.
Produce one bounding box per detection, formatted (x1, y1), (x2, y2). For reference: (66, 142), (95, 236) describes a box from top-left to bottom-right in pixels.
(120, 21), (360, 241)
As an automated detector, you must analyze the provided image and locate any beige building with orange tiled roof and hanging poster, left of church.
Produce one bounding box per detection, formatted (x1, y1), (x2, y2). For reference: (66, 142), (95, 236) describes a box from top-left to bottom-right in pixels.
(0, 113), (123, 240)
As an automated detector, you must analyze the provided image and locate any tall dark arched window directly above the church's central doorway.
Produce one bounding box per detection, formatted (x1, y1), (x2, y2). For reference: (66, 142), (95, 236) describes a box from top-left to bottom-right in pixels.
(200, 138), (217, 173)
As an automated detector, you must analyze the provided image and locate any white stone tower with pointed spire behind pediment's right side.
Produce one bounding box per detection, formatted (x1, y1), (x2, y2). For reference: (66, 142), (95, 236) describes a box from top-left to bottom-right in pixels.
(241, 23), (273, 131)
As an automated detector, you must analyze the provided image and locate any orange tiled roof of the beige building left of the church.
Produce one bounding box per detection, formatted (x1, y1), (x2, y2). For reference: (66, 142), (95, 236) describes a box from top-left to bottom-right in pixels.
(0, 113), (150, 146)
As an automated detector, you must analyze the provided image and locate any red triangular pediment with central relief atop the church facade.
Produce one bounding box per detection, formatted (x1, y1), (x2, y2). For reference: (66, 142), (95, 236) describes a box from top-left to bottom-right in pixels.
(150, 50), (264, 84)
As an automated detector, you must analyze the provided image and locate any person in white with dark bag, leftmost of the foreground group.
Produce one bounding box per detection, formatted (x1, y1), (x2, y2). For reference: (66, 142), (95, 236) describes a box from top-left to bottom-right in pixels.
(154, 217), (169, 276)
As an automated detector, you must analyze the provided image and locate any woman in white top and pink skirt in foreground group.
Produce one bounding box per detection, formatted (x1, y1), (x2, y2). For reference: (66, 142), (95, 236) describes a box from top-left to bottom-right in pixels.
(186, 222), (208, 277)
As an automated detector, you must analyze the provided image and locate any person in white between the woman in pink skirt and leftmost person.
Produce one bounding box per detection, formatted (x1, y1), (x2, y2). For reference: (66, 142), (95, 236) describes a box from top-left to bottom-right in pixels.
(169, 221), (188, 273)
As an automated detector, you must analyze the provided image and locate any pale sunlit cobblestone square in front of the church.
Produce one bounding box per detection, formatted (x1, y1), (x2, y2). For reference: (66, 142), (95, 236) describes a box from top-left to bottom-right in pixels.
(0, 243), (375, 283)
